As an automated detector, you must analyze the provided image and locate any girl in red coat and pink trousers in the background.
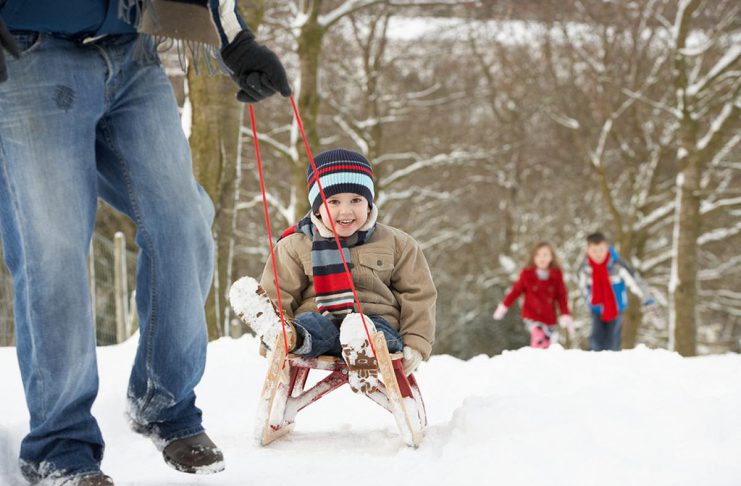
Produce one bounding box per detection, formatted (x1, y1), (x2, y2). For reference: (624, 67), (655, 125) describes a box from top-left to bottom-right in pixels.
(493, 243), (574, 348)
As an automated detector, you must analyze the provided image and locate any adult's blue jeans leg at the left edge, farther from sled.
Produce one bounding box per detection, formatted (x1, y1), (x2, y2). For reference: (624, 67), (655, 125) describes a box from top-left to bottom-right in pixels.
(0, 35), (108, 481)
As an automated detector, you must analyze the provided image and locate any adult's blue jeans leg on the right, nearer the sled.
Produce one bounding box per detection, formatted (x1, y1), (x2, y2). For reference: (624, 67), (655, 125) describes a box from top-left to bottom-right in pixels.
(90, 39), (214, 446)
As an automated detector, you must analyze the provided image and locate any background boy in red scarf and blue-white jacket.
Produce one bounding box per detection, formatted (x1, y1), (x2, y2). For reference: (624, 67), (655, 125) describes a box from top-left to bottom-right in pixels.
(578, 232), (653, 351)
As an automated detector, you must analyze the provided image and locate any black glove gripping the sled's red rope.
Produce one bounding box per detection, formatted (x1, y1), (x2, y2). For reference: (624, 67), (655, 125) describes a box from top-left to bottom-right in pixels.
(221, 30), (291, 103)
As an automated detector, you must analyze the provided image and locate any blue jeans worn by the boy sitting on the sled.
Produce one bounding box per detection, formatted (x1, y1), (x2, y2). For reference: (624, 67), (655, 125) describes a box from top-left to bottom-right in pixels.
(293, 312), (404, 358)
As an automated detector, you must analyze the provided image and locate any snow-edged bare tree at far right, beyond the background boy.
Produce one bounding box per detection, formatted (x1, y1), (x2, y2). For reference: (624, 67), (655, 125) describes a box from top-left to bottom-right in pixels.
(669, 0), (741, 356)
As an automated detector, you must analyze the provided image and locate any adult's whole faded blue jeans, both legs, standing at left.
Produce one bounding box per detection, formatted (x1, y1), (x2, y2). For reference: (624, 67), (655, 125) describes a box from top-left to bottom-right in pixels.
(0, 34), (214, 480)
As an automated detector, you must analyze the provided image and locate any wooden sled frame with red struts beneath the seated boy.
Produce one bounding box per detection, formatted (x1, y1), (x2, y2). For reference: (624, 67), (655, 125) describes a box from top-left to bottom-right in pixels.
(255, 332), (427, 448)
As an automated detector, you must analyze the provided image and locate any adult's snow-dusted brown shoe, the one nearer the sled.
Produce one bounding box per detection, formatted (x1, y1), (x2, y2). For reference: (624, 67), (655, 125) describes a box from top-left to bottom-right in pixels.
(162, 432), (225, 474)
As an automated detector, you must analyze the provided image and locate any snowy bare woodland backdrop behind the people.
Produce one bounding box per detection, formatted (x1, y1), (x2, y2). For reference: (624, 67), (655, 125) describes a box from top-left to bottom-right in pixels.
(3, 0), (741, 357)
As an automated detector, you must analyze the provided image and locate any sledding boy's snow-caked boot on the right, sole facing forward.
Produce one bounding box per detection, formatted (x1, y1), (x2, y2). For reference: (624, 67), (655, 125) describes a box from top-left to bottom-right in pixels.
(340, 314), (378, 394)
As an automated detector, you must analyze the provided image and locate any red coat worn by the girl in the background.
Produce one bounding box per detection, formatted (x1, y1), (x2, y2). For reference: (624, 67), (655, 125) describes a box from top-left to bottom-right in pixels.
(502, 267), (570, 325)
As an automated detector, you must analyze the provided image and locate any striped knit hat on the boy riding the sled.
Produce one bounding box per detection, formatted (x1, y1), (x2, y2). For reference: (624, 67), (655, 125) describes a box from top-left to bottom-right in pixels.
(307, 149), (375, 212)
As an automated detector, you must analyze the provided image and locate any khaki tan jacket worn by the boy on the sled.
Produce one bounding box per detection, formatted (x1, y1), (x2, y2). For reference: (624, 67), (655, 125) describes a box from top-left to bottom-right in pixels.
(261, 223), (437, 359)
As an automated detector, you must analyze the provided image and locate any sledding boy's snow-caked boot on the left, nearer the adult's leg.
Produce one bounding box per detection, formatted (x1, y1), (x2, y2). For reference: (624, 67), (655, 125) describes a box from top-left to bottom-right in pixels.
(229, 277), (296, 352)
